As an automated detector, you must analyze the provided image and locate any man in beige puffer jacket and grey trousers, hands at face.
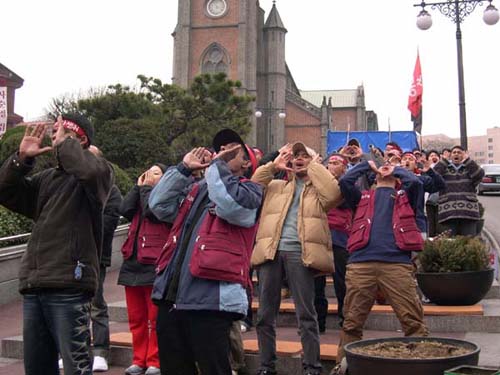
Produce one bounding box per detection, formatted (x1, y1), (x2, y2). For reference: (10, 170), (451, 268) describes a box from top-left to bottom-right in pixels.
(252, 142), (342, 375)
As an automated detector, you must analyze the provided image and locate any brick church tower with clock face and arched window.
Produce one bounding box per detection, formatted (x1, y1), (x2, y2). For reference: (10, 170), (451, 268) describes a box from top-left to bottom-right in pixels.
(172, 0), (259, 144)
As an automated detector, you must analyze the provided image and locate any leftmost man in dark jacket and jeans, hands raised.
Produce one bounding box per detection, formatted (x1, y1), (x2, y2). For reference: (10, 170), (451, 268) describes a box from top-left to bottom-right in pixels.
(0, 114), (113, 375)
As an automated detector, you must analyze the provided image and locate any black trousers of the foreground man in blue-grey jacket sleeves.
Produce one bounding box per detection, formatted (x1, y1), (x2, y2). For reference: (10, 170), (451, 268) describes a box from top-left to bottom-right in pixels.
(156, 304), (234, 375)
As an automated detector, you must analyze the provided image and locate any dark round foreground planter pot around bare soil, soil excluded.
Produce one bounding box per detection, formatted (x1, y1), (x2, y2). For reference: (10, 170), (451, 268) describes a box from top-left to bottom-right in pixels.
(344, 337), (480, 375)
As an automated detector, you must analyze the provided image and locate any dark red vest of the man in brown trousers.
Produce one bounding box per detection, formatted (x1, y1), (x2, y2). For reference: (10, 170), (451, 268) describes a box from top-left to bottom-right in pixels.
(347, 190), (424, 253)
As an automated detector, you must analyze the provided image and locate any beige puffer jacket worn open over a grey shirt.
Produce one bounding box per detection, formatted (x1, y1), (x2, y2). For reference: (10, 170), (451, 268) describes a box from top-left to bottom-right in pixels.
(252, 162), (342, 273)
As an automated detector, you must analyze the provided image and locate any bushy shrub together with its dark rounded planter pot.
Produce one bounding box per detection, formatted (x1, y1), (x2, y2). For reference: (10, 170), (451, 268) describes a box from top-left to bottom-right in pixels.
(416, 236), (494, 306)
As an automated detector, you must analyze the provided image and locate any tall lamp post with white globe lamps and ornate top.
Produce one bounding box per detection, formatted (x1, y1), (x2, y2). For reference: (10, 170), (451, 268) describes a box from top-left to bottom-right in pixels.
(413, 0), (500, 150)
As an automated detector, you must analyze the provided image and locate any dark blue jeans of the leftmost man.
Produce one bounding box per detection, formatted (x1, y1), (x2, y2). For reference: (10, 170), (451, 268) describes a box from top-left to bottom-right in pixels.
(23, 291), (92, 375)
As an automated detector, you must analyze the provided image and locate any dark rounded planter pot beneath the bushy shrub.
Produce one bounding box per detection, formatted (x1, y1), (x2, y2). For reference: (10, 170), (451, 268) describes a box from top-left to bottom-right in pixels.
(417, 269), (494, 306)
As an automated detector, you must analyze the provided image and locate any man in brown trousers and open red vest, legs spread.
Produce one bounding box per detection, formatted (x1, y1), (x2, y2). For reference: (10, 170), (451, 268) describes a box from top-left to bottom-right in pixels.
(337, 161), (428, 374)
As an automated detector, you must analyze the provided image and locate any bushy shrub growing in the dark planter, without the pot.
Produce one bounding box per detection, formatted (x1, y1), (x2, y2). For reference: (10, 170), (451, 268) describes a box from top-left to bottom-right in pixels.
(418, 236), (490, 272)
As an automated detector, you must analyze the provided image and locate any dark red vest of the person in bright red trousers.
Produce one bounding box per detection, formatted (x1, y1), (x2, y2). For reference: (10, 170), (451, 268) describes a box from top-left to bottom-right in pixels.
(122, 208), (170, 264)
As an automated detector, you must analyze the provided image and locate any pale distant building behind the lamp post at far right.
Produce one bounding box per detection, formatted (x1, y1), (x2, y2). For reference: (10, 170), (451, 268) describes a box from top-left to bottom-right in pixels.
(422, 126), (500, 164)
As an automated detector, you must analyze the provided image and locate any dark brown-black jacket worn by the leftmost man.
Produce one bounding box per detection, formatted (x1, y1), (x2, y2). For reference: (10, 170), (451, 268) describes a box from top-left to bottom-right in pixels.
(0, 138), (113, 295)
